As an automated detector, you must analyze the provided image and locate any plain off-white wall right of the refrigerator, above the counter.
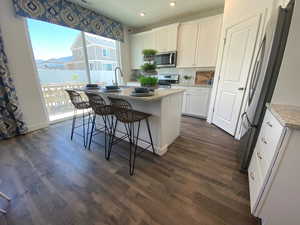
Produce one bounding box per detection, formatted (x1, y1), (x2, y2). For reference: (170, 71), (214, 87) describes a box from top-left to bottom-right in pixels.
(272, 1), (300, 106)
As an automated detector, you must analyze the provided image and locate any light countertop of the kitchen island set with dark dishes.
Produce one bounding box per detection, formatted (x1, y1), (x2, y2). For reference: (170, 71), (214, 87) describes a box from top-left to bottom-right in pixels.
(85, 87), (185, 102)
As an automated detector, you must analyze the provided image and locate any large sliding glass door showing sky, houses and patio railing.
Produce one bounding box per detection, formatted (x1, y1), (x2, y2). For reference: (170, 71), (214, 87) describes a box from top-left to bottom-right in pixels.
(27, 19), (119, 121)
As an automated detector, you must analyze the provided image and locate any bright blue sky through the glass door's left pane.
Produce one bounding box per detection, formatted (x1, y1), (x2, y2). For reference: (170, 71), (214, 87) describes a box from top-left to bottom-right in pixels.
(27, 19), (80, 60)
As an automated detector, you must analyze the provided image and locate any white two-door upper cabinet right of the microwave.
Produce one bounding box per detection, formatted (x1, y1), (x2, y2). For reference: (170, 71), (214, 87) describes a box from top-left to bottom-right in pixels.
(177, 15), (223, 67)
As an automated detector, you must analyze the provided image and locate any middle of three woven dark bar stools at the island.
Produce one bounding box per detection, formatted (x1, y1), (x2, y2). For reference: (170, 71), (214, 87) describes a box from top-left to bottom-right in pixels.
(85, 92), (114, 159)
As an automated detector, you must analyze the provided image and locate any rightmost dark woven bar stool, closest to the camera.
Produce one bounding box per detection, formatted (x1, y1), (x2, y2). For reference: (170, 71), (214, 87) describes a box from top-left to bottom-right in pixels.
(108, 97), (155, 176)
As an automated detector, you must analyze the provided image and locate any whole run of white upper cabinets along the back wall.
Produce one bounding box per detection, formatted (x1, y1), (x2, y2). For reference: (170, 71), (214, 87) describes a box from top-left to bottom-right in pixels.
(130, 15), (223, 69)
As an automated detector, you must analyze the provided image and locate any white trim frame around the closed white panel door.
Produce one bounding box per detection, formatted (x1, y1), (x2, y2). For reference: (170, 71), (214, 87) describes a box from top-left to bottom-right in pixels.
(207, 12), (268, 140)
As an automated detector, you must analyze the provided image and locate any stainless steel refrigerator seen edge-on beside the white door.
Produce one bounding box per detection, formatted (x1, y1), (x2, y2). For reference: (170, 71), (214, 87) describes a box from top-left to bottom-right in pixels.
(240, 0), (295, 172)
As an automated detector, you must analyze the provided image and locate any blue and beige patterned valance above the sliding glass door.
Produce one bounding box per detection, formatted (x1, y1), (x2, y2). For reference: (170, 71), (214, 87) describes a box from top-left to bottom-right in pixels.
(12, 0), (124, 41)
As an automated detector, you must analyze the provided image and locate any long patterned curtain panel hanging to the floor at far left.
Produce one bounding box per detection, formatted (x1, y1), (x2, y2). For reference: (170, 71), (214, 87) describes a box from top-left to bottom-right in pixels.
(0, 29), (27, 140)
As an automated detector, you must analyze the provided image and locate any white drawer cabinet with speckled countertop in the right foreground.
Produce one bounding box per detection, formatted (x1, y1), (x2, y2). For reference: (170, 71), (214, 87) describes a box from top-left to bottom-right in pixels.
(248, 105), (300, 225)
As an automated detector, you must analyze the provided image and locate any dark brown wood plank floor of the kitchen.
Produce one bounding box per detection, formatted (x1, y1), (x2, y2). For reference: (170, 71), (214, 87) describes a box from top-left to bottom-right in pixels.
(0, 117), (258, 225)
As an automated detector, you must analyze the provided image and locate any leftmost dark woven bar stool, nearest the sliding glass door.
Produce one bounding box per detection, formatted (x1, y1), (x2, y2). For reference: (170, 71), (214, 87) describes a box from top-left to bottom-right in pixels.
(65, 89), (91, 148)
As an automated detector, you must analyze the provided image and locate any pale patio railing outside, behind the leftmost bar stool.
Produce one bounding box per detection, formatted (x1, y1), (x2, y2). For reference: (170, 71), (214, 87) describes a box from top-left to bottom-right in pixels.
(42, 83), (97, 121)
